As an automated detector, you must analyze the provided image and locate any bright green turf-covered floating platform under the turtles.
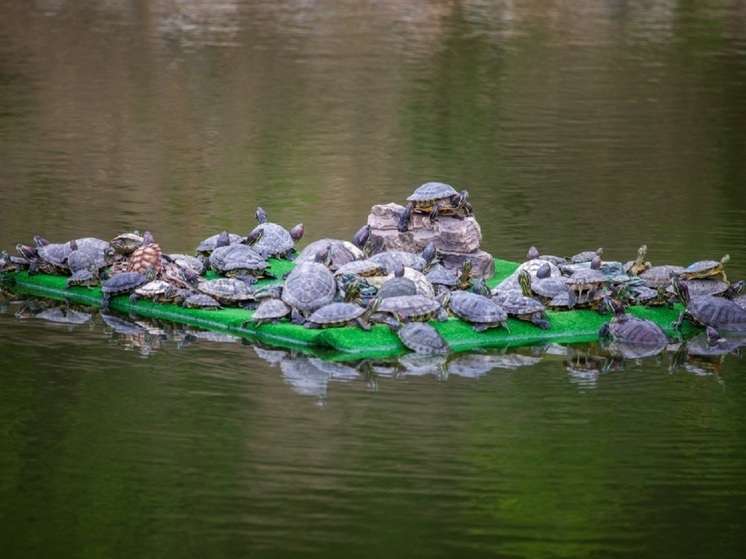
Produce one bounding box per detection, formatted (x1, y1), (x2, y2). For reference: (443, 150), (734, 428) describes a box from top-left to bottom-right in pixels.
(3, 259), (683, 359)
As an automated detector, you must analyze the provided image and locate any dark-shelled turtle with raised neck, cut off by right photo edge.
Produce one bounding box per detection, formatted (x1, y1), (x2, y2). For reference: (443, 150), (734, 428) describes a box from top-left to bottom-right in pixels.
(673, 277), (746, 332)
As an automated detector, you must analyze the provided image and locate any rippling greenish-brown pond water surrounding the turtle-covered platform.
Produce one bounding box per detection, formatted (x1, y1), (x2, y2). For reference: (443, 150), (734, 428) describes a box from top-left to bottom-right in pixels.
(0, 0), (746, 558)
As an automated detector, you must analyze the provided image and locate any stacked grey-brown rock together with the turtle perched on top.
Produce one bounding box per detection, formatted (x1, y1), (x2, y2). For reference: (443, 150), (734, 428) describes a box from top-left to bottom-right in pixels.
(365, 182), (495, 278)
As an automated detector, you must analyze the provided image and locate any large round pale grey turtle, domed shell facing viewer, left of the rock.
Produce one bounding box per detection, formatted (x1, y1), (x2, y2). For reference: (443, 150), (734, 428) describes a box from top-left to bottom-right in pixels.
(282, 255), (337, 323)
